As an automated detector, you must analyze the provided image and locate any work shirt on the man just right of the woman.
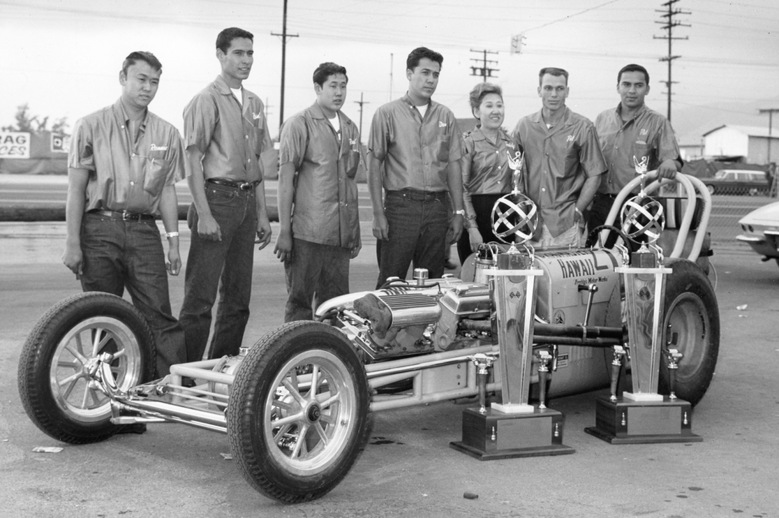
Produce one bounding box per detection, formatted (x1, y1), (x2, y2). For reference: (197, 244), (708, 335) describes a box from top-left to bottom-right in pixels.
(513, 107), (606, 237)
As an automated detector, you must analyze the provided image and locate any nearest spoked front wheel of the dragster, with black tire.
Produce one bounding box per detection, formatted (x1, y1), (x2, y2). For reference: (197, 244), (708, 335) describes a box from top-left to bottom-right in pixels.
(227, 322), (372, 503)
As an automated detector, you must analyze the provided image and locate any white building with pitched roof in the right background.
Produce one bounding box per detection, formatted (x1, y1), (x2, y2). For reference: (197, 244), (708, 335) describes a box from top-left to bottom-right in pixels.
(703, 124), (779, 164)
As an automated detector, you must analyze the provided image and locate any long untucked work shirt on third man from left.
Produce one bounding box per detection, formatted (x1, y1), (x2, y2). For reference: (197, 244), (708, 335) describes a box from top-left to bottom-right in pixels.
(279, 103), (360, 249)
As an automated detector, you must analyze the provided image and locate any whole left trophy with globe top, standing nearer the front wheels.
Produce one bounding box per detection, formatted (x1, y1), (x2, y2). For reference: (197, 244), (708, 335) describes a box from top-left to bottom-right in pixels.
(450, 152), (574, 460)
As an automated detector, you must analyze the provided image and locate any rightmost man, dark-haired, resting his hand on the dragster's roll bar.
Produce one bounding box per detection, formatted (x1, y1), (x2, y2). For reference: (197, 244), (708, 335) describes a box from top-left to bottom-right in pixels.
(588, 64), (682, 239)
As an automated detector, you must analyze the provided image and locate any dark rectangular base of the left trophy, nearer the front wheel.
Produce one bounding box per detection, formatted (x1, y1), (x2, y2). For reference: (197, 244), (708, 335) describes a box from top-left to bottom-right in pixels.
(449, 407), (575, 460)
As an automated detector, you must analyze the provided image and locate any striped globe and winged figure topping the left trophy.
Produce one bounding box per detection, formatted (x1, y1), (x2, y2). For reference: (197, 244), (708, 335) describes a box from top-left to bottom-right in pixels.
(492, 150), (538, 253)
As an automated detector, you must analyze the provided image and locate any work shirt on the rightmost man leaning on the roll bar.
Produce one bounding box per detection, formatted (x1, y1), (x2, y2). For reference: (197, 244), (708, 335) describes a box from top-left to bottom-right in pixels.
(595, 103), (682, 194)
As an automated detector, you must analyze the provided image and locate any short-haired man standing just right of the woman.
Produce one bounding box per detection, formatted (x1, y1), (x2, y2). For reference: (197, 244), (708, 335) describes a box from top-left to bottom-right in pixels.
(513, 68), (606, 248)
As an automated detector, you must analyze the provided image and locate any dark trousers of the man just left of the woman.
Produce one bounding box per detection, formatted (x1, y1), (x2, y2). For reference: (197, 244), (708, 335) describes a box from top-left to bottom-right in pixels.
(376, 190), (449, 288)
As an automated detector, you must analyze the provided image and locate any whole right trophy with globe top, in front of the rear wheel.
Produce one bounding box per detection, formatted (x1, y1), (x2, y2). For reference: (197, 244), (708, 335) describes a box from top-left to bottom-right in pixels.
(585, 157), (702, 444)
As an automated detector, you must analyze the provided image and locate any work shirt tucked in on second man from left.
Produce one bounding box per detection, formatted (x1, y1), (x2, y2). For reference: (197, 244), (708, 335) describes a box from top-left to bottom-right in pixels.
(184, 76), (272, 182)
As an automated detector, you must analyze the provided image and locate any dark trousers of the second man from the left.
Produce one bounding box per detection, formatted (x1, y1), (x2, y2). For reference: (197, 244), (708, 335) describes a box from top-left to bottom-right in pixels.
(179, 183), (257, 361)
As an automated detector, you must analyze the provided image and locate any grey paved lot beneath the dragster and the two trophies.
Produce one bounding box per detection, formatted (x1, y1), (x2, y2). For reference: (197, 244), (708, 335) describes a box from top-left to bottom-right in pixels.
(0, 223), (779, 518)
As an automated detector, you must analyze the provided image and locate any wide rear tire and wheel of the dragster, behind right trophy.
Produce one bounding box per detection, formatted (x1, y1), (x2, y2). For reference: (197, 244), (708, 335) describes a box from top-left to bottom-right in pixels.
(659, 259), (720, 406)
